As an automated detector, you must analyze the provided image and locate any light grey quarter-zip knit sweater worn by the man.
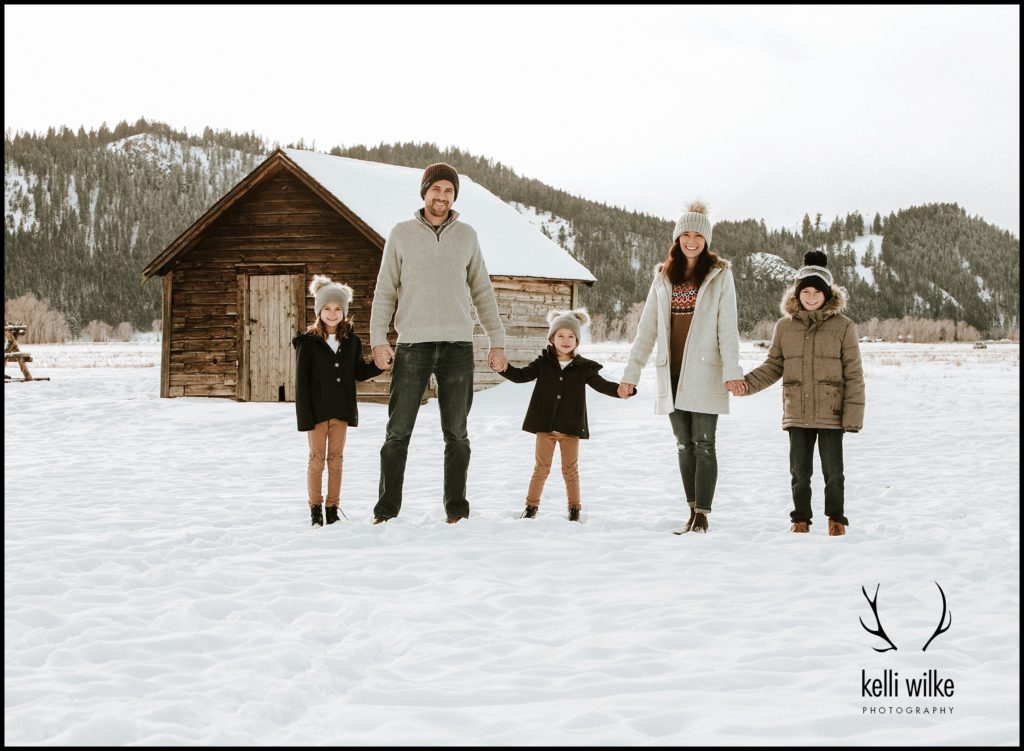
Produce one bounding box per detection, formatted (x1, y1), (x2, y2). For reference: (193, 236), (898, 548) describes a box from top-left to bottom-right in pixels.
(370, 211), (505, 347)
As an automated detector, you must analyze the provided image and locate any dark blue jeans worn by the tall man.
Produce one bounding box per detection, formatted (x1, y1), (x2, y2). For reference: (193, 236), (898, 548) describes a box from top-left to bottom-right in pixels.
(374, 341), (474, 518)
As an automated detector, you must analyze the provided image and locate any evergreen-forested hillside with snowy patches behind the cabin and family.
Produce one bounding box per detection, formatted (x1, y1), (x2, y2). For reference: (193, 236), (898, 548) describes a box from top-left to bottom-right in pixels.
(4, 120), (1020, 336)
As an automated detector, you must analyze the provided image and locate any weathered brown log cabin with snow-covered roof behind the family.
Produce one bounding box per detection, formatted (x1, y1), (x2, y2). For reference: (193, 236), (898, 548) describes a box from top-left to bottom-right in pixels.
(142, 149), (596, 403)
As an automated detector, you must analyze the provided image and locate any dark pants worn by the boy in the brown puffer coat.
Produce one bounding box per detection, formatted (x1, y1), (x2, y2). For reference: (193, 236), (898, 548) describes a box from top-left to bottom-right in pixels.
(788, 427), (850, 526)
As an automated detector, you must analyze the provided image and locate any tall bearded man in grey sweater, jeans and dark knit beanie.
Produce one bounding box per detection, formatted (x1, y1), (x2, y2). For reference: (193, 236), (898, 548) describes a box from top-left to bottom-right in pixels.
(370, 162), (506, 525)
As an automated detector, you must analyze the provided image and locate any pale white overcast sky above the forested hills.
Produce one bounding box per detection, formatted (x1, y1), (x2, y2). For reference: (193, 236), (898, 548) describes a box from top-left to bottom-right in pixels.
(4, 5), (1020, 235)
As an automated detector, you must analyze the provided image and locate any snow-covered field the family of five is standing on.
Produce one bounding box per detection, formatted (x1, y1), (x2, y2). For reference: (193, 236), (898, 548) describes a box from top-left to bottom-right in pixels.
(4, 343), (1020, 746)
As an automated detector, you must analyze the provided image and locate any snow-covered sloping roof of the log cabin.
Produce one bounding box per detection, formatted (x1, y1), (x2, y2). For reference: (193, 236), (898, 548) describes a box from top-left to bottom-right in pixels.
(282, 149), (597, 282)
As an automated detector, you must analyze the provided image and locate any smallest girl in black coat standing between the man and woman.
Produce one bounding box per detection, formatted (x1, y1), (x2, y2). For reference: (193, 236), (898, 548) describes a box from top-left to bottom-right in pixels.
(500, 308), (618, 521)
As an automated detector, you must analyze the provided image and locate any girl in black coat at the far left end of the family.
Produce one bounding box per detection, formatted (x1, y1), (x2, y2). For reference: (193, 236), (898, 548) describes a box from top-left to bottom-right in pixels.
(292, 276), (383, 527)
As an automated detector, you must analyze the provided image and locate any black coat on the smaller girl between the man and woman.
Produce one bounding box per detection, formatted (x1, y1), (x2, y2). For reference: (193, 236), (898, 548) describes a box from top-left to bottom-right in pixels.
(502, 346), (618, 439)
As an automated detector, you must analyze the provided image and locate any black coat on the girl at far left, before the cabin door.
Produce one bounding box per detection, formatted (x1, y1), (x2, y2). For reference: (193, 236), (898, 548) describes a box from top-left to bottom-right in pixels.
(292, 332), (384, 431)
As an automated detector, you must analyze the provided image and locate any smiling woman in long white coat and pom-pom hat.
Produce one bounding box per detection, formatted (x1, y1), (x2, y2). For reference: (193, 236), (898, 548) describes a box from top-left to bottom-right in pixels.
(618, 202), (746, 535)
